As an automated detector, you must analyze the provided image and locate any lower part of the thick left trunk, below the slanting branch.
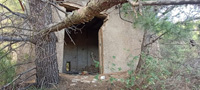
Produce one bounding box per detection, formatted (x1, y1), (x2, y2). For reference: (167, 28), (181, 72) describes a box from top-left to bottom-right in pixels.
(35, 33), (59, 87)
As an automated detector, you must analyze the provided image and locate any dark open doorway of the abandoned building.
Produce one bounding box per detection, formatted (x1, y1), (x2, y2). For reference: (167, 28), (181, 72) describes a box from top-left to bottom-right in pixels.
(63, 17), (105, 74)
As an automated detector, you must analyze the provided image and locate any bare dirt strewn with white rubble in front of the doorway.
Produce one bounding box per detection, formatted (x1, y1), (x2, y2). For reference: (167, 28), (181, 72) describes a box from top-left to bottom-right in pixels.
(53, 72), (128, 90)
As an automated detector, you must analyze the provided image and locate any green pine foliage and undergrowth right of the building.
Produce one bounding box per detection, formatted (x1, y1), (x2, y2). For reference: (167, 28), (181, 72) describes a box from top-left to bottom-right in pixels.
(115, 4), (200, 90)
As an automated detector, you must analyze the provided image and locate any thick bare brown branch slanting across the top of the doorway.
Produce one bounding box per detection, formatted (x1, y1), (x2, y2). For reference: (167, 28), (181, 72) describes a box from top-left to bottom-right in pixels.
(39, 0), (126, 35)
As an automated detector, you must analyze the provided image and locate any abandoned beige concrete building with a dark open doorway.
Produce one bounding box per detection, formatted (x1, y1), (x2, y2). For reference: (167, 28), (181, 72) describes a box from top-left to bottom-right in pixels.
(16, 0), (143, 74)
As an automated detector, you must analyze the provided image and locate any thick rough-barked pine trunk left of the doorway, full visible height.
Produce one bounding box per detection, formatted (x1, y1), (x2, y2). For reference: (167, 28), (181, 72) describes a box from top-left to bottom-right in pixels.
(29, 0), (59, 87)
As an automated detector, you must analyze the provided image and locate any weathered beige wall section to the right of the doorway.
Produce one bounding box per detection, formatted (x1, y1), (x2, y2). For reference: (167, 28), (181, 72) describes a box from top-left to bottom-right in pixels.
(102, 8), (143, 73)
